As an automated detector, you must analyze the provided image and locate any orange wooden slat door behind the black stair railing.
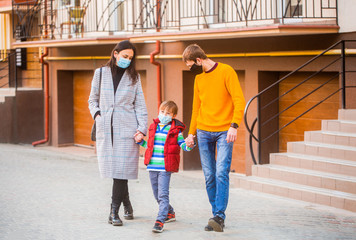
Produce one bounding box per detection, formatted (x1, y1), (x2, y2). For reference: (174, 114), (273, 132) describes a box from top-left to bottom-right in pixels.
(279, 73), (339, 152)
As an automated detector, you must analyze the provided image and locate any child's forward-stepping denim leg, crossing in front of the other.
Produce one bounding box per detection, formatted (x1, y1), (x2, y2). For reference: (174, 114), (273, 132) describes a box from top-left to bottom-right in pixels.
(157, 172), (173, 223)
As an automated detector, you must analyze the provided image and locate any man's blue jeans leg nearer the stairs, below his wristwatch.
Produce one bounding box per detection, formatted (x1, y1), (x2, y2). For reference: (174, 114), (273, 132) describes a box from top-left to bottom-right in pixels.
(214, 132), (234, 219)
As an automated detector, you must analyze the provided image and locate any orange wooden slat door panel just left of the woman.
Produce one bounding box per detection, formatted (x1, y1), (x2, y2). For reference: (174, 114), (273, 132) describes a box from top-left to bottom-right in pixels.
(73, 71), (94, 146)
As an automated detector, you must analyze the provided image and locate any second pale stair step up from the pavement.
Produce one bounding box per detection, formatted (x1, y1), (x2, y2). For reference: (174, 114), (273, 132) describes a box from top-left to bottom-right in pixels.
(252, 164), (356, 194)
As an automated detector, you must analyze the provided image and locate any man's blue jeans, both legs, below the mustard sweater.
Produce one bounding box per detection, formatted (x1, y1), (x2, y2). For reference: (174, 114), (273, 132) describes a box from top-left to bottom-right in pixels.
(197, 129), (234, 219)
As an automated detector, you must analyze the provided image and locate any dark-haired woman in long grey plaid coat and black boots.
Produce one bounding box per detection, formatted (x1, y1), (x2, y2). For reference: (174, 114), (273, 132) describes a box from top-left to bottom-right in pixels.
(88, 41), (147, 226)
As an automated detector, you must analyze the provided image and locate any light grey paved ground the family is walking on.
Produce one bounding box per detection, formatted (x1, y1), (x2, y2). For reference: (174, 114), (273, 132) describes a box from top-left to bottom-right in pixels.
(0, 144), (356, 240)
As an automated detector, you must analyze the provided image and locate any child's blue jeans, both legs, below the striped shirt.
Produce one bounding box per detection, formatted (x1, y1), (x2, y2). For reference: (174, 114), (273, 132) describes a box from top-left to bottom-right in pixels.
(150, 171), (174, 223)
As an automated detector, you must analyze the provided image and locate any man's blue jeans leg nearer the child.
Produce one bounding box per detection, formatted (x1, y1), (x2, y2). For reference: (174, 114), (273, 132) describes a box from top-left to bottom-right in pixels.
(197, 129), (216, 217)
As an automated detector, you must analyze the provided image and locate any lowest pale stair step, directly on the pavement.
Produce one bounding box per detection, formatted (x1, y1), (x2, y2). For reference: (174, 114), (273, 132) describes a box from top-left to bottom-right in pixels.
(234, 176), (356, 212)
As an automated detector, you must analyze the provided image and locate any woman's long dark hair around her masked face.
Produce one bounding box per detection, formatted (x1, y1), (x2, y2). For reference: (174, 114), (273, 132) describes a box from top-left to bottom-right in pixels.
(106, 40), (138, 83)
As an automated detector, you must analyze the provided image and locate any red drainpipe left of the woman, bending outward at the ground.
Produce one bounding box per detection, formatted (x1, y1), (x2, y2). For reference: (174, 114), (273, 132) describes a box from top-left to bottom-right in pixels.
(32, 47), (49, 146)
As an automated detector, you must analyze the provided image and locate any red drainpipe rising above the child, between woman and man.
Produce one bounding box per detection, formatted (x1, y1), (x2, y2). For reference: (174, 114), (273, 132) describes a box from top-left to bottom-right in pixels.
(150, 0), (162, 110)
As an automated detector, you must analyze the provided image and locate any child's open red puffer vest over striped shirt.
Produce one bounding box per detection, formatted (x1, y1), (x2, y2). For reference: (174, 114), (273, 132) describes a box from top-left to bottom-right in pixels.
(145, 118), (185, 172)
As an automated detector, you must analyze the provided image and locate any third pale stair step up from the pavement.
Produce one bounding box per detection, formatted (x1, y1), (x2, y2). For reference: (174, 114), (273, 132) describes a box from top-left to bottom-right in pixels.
(270, 153), (356, 177)
